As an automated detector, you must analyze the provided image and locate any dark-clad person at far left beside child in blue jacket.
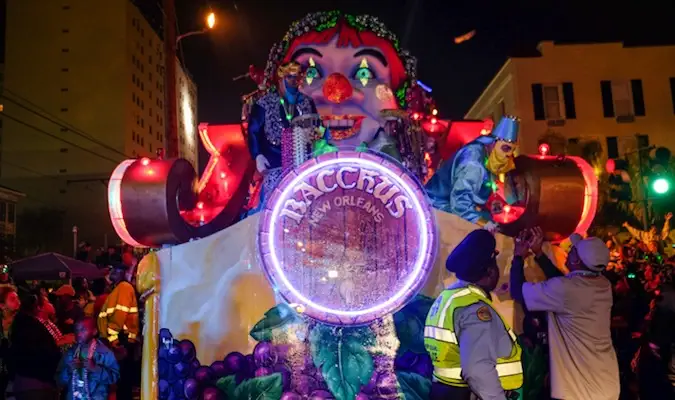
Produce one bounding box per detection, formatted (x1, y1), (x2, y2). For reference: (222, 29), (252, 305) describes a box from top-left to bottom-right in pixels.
(9, 294), (61, 400)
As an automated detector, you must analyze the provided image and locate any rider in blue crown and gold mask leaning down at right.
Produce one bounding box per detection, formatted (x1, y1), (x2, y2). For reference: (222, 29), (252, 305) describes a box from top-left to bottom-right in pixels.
(426, 116), (519, 232)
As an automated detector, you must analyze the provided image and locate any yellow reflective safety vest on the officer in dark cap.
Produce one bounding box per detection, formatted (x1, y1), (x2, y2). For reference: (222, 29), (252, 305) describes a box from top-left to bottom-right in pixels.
(424, 285), (523, 390)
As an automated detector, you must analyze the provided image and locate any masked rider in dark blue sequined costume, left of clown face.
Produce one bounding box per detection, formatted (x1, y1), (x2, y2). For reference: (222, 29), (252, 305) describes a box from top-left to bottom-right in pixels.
(248, 62), (324, 214)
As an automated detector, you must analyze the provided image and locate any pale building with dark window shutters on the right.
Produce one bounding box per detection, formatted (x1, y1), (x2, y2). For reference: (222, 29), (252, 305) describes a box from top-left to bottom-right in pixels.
(465, 42), (675, 158)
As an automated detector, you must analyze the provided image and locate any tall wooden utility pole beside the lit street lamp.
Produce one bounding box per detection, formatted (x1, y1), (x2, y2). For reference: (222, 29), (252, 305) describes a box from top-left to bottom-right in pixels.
(163, 0), (178, 158)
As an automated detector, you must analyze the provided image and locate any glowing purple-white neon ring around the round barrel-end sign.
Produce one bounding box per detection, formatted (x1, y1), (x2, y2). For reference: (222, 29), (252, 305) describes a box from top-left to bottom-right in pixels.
(258, 151), (437, 325)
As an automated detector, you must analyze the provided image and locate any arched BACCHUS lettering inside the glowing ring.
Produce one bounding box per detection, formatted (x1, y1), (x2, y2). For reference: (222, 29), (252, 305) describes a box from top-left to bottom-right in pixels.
(280, 166), (412, 223)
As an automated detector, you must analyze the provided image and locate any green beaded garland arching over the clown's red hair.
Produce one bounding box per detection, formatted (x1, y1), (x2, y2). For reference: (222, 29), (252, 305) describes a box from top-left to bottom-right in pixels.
(262, 10), (417, 108)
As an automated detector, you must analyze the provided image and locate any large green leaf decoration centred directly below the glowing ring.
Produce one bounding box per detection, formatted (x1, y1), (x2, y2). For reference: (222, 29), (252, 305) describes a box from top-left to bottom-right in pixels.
(309, 325), (374, 400)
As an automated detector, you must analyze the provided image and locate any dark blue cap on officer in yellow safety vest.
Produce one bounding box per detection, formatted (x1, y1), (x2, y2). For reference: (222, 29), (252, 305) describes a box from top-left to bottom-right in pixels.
(445, 229), (497, 282)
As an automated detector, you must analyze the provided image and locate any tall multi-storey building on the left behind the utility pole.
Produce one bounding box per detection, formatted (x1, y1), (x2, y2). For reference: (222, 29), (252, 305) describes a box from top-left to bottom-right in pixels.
(0, 0), (196, 252)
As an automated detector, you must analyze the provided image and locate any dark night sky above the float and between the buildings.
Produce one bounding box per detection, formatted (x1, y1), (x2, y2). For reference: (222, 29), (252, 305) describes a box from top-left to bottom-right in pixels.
(0, 0), (675, 123)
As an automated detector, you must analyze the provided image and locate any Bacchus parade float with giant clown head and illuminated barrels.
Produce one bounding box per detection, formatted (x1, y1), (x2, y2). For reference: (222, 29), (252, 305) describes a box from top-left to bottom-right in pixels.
(109, 12), (597, 400)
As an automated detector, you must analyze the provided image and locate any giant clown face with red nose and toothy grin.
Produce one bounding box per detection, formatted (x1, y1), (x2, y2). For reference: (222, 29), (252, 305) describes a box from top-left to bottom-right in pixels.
(290, 37), (398, 146)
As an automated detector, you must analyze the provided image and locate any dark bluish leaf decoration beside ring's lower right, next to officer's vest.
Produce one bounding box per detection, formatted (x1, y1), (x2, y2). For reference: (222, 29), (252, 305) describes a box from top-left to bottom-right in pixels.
(394, 295), (434, 354)
